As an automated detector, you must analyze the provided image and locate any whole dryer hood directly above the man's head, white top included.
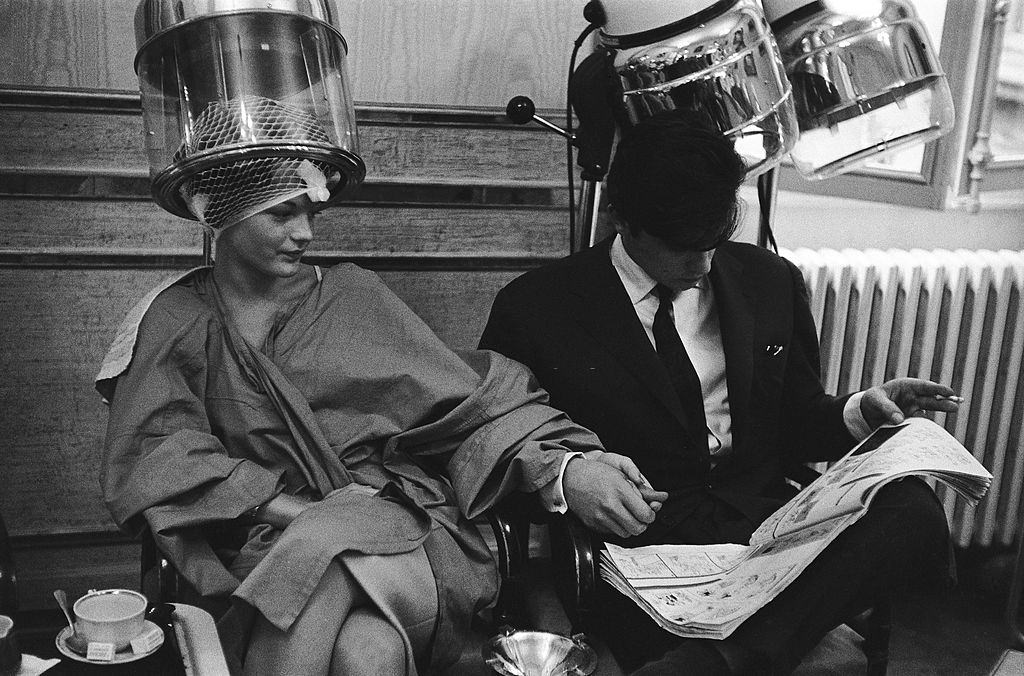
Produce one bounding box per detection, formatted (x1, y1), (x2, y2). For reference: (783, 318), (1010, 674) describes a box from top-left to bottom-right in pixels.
(599, 0), (798, 175)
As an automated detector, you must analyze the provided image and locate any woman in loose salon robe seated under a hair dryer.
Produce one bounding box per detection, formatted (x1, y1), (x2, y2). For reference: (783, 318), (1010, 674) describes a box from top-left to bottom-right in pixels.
(97, 145), (656, 674)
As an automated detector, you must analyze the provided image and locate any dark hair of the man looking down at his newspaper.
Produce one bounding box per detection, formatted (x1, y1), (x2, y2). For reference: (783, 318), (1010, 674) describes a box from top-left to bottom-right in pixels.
(608, 110), (746, 250)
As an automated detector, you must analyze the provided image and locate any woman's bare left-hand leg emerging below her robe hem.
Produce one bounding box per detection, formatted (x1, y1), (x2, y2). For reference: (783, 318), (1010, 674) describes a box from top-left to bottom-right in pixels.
(245, 561), (368, 676)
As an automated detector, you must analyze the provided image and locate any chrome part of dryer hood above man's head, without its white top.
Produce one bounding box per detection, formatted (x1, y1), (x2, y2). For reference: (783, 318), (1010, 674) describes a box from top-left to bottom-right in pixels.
(601, 0), (797, 174)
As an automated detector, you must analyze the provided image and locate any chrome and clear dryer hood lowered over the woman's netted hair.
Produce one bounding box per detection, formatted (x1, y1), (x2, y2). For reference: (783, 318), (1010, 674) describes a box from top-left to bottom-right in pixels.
(135, 0), (366, 220)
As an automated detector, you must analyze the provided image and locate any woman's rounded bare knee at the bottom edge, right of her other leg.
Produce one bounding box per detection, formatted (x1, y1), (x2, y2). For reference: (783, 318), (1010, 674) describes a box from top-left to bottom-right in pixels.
(331, 607), (406, 676)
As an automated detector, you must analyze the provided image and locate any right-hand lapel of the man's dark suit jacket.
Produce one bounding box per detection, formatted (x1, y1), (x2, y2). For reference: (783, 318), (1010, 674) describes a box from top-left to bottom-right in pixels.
(709, 247), (754, 455)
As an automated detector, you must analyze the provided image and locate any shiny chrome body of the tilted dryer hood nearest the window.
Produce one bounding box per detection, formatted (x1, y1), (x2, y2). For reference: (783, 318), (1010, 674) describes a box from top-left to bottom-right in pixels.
(772, 0), (953, 178)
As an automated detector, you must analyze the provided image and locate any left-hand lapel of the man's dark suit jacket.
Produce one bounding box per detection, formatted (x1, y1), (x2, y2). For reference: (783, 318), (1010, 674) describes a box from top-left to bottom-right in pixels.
(566, 240), (689, 429)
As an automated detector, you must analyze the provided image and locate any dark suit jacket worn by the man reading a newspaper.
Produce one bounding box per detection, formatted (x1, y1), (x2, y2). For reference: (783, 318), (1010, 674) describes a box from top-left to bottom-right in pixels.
(480, 240), (854, 546)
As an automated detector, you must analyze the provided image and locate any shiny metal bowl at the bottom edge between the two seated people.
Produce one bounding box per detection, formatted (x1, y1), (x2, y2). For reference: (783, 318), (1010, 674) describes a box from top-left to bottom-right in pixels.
(482, 628), (597, 676)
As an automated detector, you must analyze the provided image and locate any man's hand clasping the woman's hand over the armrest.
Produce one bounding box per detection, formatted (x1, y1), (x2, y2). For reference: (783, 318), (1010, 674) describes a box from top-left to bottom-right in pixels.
(562, 453), (669, 538)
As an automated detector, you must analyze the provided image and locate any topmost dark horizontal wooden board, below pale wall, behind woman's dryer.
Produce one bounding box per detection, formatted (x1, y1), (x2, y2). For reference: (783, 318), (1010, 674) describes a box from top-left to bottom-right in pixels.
(0, 109), (565, 187)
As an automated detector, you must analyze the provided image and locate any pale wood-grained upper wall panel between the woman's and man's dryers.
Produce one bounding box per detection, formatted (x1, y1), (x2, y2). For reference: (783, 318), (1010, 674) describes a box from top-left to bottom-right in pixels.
(337, 0), (586, 109)
